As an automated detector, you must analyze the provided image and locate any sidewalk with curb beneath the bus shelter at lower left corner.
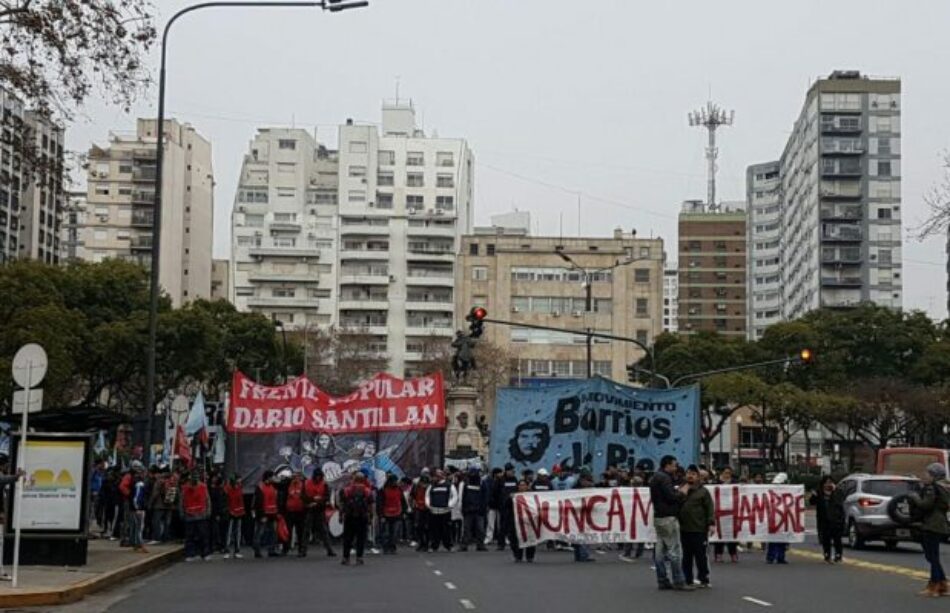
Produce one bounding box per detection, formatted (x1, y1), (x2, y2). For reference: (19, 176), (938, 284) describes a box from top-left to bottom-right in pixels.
(0, 539), (183, 609)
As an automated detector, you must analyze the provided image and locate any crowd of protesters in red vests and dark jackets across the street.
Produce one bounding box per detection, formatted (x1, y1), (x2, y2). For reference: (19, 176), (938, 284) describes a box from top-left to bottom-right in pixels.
(85, 456), (950, 596)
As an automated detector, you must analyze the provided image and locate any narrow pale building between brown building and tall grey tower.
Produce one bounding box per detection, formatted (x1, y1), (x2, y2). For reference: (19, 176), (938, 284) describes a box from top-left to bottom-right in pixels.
(746, 162), (782, 341)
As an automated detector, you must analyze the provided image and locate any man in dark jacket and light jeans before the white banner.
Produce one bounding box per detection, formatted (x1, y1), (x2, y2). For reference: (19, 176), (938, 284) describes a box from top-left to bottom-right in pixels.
(650, 455), (693, 590)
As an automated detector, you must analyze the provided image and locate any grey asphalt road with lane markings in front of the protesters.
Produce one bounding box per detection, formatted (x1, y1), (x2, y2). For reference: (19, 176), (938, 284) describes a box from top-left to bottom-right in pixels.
(41, 544), (950, 613)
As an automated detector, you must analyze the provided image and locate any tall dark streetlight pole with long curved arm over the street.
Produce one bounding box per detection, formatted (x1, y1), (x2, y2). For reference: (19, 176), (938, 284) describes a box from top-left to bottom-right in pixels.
(145, 0), (369, 444)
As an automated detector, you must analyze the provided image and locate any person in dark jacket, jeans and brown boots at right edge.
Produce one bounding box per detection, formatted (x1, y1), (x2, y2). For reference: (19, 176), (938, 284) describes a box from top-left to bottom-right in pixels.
(910, 462), (950, 597)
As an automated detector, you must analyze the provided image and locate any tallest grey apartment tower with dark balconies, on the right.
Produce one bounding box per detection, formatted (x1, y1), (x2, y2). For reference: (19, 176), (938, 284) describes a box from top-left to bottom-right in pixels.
(750, 71), (902, 320)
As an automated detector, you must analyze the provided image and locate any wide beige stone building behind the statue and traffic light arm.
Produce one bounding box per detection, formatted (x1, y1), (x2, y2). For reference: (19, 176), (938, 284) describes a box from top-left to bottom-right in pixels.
(455, 230), (664, 392)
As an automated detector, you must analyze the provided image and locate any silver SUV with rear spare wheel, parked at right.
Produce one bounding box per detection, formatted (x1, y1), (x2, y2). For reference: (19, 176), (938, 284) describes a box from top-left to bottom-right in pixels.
(838, 474), (920, 549)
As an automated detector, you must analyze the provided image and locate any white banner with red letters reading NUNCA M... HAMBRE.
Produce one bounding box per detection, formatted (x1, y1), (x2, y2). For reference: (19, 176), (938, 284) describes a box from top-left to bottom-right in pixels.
(514, 485), (805, 547)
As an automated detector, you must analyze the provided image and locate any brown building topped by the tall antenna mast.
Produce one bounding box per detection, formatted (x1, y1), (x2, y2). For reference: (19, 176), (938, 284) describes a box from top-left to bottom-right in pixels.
(679, 200), (746, 336)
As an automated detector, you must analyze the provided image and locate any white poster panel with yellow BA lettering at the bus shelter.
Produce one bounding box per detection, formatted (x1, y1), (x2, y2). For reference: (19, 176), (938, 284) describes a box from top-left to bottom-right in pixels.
(12, 438), (86, 531)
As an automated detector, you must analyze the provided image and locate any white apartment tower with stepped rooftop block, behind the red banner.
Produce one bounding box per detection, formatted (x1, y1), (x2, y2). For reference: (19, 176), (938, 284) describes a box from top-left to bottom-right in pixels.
(336, 101), (474, 375)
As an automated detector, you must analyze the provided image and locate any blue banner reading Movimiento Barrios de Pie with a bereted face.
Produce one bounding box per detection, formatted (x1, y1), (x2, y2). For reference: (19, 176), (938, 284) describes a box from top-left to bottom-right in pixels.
(491, 377), (700, 474)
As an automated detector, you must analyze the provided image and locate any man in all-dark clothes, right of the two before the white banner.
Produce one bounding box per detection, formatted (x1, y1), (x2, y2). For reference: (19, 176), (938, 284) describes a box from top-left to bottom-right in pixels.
(678, 465), (716, 587)
